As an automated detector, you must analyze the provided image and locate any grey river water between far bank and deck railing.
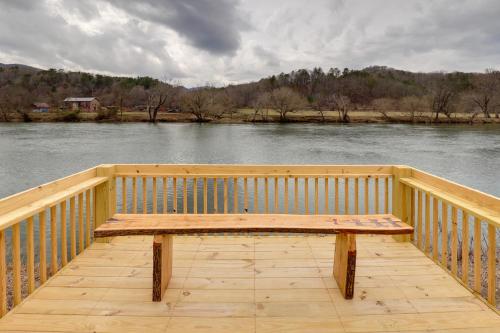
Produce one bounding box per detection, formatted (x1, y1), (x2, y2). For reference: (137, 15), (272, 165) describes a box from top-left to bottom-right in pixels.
(0, 123), (500, 198)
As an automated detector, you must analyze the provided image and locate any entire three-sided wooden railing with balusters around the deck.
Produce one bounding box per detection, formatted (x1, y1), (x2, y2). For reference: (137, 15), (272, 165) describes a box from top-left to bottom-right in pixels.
(0, 165), (500, 315)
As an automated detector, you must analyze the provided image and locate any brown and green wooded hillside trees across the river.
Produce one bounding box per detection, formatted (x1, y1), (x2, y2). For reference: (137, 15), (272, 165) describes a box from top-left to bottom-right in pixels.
(0, 66), (500, 122)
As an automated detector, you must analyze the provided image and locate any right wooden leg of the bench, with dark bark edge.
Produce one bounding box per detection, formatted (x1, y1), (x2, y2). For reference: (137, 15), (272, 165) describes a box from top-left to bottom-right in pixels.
(333, 233), (356, 299)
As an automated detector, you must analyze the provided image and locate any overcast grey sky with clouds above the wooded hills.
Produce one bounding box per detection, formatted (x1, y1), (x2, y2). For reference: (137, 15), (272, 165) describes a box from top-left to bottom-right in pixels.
(0, 0), (500, 86)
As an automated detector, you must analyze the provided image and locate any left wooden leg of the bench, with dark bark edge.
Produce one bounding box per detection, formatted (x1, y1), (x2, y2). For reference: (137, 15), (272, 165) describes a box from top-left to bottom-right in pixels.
(153, 235), (173, 302)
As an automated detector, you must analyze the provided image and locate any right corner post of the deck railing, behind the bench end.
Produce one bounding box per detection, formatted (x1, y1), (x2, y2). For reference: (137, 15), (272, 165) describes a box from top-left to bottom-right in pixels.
(392, 165), (412, 242)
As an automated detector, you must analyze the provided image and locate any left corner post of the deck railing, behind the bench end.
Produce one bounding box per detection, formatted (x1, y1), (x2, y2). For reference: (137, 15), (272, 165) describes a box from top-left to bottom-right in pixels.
(94, 164), (116, 242)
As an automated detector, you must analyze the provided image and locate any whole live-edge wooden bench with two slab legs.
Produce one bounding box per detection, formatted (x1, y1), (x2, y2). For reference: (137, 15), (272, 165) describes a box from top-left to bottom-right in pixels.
(94, 214), (413, 301)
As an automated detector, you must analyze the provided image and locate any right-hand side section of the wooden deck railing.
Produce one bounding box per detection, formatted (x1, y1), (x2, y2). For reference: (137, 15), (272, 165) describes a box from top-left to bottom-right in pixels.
(399, 169), (500, 307)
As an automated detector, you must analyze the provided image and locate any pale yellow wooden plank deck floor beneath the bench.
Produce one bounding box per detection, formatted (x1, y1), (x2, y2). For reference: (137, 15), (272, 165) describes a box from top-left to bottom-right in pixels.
(0, 235), (500, 333)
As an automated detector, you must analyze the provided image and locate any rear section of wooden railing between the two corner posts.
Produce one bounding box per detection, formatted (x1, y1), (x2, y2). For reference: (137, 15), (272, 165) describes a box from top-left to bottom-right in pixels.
(115, 165), (392, 214)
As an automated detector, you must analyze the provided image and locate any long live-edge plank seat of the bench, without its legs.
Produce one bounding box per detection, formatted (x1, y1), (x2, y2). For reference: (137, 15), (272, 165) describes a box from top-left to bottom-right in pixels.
(94, 214), (413, 237)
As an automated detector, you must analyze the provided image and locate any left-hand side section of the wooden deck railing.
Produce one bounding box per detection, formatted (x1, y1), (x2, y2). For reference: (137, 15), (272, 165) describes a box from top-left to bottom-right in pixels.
(0, 166), (112, 316)
